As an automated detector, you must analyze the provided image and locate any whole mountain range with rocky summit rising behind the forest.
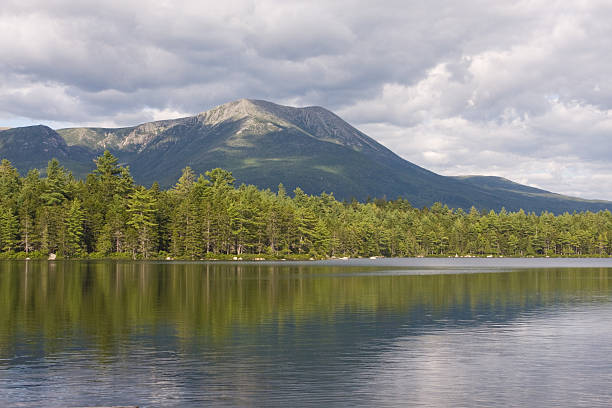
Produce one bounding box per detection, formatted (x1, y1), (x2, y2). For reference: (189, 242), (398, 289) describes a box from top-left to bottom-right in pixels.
(0, 99), (612, 212)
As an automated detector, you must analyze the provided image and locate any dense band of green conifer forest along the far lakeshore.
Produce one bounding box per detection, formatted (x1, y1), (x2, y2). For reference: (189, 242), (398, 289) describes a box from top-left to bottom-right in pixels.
(0, 152), (612, 259)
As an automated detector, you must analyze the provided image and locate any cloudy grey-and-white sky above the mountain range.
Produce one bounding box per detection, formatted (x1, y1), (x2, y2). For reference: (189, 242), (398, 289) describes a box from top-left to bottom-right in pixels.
(0, 0), (612, 200)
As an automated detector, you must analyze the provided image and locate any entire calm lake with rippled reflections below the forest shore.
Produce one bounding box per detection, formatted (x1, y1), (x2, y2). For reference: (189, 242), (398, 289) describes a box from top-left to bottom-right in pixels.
(0, 259), (612, 407)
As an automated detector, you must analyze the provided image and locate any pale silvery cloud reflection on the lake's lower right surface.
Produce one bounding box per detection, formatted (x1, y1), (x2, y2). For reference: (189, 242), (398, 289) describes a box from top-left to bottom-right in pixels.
(364, 303), (612, 407)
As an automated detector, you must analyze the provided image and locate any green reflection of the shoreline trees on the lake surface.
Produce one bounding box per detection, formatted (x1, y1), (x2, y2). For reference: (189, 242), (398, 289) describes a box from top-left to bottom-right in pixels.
(0, 262), (612, 354)
